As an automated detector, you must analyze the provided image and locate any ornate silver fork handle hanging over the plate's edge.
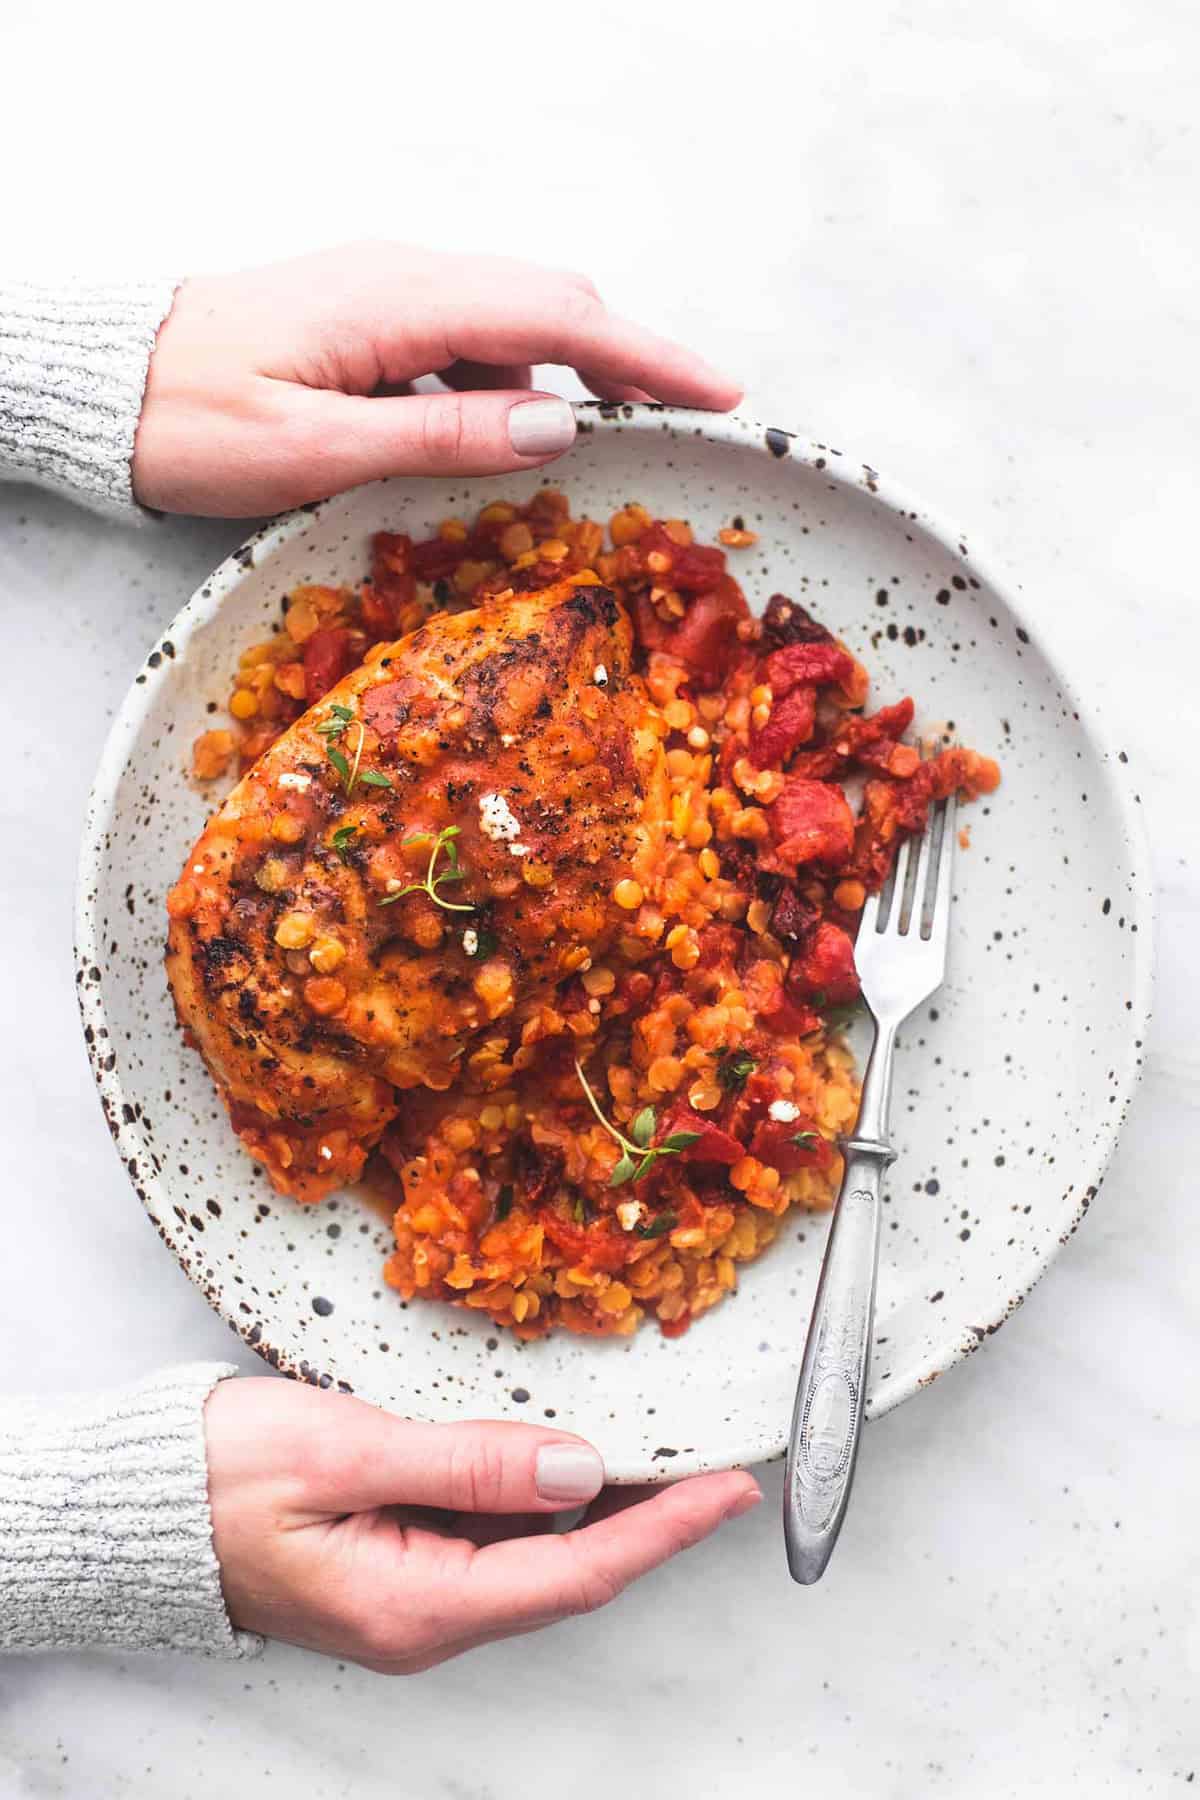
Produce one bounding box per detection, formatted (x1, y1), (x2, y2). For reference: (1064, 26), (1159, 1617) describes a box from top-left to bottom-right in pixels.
(783, 1138), (896, 1586)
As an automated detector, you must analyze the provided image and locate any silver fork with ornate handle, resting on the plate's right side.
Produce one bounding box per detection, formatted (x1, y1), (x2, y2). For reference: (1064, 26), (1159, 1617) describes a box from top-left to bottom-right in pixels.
(783, 796), (955, 1586)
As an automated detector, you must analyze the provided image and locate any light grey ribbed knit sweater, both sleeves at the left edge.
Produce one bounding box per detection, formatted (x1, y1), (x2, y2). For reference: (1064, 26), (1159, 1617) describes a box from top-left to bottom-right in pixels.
(0, 279), (263, 1656)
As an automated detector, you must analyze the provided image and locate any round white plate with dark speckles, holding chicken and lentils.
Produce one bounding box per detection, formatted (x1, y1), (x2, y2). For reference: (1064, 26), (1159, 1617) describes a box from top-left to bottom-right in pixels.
(77, 407), (1151, 1481)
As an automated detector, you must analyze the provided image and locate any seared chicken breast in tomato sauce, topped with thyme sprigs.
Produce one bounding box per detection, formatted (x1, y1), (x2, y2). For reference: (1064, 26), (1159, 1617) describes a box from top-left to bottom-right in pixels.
(167, 581), (666, 1201)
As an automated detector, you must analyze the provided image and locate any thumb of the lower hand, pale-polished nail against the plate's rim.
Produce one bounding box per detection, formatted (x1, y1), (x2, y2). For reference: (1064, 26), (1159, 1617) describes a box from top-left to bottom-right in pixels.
(304, 1400), (604, 1512)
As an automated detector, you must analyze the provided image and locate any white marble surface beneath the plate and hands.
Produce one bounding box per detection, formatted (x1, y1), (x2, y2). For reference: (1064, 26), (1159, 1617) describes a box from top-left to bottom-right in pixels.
(0, 0), (1200, 1800)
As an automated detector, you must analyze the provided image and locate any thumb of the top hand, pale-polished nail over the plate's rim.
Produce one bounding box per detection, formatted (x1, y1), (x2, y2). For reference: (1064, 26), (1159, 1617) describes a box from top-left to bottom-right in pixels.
(289, 389), (576, 488)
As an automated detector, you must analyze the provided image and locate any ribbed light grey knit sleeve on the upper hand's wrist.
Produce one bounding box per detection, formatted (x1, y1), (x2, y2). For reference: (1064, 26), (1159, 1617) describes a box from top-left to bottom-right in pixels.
(0, 275), (178, 518)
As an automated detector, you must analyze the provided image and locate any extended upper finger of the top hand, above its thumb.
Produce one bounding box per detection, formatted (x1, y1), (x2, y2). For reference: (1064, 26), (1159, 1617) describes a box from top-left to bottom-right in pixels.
(446, 298), (741, 412)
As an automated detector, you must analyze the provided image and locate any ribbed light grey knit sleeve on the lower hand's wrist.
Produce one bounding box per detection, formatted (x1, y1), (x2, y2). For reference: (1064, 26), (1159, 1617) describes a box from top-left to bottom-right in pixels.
(0, 1363), (263, 1658)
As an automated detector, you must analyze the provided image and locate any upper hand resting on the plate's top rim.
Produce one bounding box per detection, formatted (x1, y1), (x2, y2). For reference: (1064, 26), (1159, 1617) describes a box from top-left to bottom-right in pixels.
(133, 243), (741, 517)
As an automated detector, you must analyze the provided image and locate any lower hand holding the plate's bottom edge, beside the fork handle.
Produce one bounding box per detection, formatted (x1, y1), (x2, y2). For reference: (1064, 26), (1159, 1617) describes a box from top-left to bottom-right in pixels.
(205, 1377), (763, 1674)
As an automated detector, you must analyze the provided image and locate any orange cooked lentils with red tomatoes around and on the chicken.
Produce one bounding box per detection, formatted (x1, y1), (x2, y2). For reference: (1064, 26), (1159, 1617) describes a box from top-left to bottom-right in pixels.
(171, 488), (999, 1337)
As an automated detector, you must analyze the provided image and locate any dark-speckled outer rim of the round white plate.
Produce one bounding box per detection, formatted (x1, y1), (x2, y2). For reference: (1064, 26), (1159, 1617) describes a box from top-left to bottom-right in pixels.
(74, 401), (1157, 1481)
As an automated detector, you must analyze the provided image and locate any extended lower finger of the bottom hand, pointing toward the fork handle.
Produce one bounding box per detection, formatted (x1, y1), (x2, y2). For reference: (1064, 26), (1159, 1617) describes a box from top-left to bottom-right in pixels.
(462, 1472), (763, 1633)
